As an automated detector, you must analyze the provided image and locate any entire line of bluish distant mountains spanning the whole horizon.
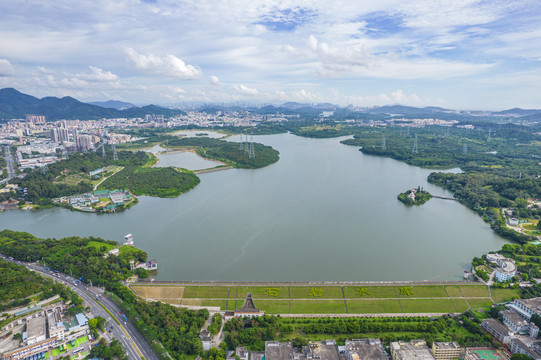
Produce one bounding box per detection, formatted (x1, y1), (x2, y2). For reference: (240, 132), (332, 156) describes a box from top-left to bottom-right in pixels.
(0, 88), (541, 121)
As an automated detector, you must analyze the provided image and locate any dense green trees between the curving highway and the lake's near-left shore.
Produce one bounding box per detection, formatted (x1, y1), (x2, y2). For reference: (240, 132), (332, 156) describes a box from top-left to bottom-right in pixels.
(0, 230), (209, 360)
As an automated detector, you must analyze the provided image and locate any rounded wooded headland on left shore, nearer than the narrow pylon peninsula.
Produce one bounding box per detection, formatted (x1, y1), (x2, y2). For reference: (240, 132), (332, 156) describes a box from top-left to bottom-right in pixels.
(99, 166), (200, 197)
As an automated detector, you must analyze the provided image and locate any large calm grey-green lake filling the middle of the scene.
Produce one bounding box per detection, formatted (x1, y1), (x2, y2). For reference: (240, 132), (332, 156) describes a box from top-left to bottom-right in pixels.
(0, 134), (505, 281)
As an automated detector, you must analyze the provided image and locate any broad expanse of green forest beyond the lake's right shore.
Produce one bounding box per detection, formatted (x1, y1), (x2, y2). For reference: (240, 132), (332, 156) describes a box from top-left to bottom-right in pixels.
(342, 123), (541, 243)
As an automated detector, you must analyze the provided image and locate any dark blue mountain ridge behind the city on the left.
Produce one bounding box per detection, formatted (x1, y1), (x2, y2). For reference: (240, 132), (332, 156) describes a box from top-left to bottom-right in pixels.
(0, 88), (185, 120)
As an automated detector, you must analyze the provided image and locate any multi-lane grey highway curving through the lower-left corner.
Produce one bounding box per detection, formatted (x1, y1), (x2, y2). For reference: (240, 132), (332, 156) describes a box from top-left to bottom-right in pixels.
(2, 256), (158, 360)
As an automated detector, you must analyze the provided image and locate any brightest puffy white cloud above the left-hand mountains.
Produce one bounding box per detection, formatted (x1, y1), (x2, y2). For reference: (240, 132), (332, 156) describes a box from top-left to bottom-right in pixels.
(125, 48), (203, 80)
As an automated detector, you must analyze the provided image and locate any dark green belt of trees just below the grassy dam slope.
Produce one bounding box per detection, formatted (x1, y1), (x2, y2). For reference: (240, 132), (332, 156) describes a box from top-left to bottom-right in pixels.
(224, 314), (493, 351)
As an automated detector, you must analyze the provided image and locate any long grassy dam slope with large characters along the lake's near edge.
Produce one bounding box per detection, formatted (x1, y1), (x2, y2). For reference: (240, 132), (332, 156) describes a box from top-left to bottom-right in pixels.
(132, 284), (519, 314)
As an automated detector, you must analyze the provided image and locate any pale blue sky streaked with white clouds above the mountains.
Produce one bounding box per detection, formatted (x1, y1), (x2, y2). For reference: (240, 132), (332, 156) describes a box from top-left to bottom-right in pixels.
(0, 0), (541, 109)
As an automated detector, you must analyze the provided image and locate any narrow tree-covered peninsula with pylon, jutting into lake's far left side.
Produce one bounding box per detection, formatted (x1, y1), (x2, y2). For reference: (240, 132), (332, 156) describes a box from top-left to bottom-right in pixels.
(165, 138), (279, 169)
